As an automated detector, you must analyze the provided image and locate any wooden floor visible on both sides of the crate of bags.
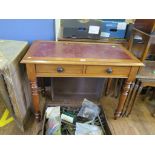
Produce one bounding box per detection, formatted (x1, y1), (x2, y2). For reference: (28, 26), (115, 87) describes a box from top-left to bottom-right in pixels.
(0, 94), (155, 135)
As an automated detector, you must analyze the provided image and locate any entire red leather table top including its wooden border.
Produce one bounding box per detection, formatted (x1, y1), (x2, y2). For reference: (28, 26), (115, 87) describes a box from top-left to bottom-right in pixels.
(22, 41), (142, 66)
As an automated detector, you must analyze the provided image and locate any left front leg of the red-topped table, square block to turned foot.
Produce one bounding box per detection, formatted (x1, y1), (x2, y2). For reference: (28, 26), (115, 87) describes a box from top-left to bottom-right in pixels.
(26, 64), (41, 121)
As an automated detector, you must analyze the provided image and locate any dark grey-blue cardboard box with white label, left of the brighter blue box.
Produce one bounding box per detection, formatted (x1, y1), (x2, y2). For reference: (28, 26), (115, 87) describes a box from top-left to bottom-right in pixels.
(61, 19), (102, 39)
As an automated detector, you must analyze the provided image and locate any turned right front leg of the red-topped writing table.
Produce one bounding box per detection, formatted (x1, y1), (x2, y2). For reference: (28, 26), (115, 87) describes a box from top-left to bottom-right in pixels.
(114, 80), (132, 119)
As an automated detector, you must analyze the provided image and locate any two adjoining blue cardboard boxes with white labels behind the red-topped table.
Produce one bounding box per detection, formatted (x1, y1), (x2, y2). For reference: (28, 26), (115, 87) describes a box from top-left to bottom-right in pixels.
(61, 19), (128, 39)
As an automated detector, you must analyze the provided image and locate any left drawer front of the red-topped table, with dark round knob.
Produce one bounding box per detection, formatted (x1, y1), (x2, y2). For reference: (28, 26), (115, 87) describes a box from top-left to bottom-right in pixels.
(36, 64), (83, 74)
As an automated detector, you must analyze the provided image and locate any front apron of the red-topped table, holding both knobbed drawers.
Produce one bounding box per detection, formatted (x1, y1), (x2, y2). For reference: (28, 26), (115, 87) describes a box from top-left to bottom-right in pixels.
(35, 64), (131, 78)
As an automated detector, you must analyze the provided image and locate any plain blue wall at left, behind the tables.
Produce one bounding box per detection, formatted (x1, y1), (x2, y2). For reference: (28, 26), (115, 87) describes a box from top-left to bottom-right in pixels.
(0, 19), (55, 43)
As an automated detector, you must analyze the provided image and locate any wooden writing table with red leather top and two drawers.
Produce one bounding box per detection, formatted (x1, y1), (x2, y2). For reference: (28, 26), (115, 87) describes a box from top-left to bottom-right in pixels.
(21, 41), (143, 120)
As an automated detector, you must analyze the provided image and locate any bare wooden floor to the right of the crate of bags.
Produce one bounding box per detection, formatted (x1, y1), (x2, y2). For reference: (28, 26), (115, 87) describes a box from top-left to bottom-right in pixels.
(101, 97), (155, 135)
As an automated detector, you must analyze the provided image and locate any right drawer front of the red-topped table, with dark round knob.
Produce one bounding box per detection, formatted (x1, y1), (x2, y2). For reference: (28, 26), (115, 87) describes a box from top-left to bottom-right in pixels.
(86, 66), (130, 77)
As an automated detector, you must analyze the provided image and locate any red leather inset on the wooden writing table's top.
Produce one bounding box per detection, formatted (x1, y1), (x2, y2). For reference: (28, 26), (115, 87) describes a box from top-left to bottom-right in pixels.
(28, 41), (131, 59)
